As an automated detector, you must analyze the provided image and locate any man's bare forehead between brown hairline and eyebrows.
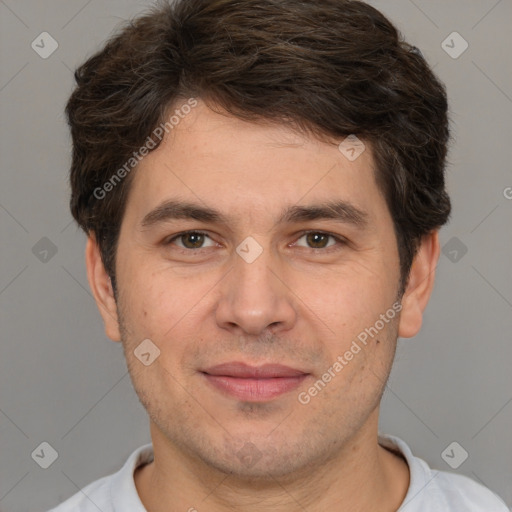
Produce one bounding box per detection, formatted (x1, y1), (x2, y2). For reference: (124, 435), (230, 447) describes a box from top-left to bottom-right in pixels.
(123, 102), (386, 228)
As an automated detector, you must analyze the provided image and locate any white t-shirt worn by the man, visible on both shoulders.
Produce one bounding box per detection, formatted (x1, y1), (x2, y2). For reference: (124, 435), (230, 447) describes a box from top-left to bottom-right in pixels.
(49, 435), (509, 512)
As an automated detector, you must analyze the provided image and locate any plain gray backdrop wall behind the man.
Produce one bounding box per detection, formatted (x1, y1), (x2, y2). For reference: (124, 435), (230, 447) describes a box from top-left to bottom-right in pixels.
(0, 0), (512, 512)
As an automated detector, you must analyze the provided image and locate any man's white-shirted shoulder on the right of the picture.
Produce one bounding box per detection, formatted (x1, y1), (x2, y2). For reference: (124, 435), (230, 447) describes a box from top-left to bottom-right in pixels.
(379, 435), (509, 512)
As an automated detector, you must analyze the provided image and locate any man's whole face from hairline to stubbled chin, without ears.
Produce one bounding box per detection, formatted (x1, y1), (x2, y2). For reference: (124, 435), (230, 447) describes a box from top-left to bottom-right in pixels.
(106, 102), (406, 477)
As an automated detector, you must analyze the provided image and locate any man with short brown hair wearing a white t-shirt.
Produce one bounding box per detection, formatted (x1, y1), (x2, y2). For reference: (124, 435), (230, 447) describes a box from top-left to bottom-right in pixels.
(49, 0), (507, 512)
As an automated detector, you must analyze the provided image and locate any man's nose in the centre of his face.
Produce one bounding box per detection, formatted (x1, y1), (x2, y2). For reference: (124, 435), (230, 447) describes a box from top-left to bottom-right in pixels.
(216, 244), (297, 336)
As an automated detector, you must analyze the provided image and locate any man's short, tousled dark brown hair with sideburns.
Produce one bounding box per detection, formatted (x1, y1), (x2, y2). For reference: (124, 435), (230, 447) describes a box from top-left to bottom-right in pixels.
(66, 0), (450, 289)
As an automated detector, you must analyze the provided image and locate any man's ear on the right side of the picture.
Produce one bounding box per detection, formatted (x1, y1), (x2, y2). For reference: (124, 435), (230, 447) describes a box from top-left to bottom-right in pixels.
(398, 230), (440, 338)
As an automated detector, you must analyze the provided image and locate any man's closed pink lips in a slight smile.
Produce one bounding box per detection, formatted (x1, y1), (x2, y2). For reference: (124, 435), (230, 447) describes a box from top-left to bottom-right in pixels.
(201, 362), (310, 402)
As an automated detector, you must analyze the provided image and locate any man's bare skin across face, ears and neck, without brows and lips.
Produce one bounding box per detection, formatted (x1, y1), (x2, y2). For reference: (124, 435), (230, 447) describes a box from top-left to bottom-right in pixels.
(86, 101), (439, 512)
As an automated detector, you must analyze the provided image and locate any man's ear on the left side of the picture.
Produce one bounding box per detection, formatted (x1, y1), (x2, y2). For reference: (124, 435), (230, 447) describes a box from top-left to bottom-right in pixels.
(85, 235), (121, 341)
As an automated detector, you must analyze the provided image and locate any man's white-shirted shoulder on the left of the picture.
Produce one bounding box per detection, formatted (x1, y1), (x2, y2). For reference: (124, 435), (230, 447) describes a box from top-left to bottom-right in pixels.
(48, 444), (153, 512)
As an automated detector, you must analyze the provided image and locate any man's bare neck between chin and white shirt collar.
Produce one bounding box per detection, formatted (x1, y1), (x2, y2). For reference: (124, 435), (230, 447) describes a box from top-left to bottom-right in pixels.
(134, 414), (409, 512)
